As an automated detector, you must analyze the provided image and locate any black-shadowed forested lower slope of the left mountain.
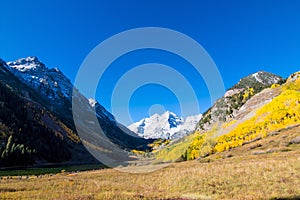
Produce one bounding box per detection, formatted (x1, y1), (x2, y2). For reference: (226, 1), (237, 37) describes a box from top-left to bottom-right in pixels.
(0, 82), (74, 166)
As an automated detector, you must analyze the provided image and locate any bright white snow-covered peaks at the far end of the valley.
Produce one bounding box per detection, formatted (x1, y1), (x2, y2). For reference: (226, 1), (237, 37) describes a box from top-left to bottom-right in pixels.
(127, 111), (202, 139)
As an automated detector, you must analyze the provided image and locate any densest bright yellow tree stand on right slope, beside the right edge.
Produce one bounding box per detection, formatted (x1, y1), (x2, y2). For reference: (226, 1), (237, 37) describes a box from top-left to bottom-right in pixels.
(214, 84), (300, 152)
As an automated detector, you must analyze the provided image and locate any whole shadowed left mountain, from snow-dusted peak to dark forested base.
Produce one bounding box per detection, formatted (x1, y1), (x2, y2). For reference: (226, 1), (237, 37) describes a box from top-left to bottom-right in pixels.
(0, 57), (151, 166)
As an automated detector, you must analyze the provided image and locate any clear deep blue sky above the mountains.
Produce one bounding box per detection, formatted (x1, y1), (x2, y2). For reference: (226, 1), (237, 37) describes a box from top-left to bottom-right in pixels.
(0, 0), (300, 124)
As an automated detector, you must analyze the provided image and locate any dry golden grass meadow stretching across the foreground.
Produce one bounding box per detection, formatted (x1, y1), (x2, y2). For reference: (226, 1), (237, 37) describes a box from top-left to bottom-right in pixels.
(0, 127), (300, 200)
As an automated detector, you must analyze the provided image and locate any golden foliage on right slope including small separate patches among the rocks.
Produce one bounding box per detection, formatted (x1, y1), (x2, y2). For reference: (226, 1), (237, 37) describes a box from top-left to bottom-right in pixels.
(186, 76), (300, 160)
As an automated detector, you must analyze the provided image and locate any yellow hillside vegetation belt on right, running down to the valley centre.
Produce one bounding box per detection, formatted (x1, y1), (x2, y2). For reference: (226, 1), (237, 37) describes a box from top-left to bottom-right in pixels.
(156, 73), (300, 161)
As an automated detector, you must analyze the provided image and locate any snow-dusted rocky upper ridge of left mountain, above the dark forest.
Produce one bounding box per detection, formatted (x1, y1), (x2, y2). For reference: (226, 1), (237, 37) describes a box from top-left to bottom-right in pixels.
(3, 56), (151, 149)
